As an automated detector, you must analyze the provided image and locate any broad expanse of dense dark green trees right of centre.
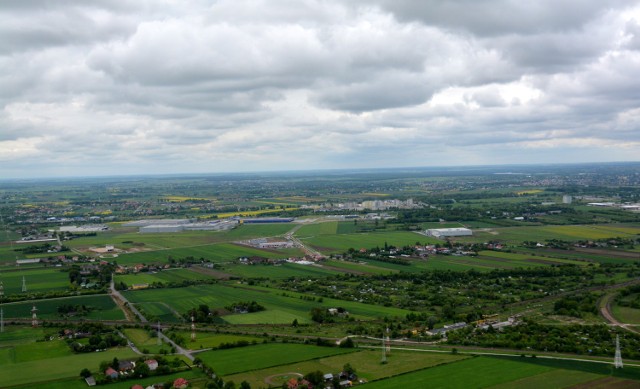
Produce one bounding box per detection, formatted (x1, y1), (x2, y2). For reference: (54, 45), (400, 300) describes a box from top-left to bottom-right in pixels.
(276, 264), (608, 316)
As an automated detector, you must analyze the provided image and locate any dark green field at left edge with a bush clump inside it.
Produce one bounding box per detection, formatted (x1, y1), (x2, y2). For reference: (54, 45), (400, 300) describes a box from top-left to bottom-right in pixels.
(2, 295), (125, 320)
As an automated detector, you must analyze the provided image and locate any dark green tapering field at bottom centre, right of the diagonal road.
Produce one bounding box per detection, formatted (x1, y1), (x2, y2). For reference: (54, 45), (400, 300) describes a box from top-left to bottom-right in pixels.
(198, 343), (354, 376)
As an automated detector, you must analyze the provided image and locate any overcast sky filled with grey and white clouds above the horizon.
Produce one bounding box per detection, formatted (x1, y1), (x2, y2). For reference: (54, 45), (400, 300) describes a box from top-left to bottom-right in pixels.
(0, 0), (640, 178)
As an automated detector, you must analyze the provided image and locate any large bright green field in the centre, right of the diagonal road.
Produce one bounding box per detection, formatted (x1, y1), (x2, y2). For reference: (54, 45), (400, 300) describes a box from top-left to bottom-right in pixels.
(124, 284), (409, 324)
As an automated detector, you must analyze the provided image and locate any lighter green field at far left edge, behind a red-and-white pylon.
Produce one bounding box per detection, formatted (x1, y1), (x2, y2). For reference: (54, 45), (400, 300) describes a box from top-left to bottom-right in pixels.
(0, 267), (69, 295)
